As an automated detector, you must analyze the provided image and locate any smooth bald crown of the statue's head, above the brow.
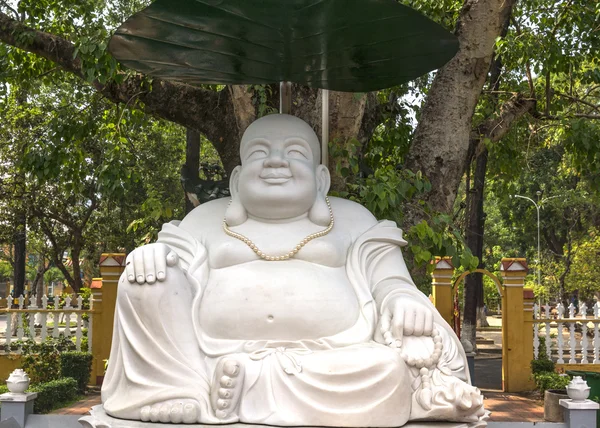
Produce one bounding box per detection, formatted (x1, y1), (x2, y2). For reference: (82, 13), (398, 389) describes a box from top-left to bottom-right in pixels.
(240, 114), (321, 167)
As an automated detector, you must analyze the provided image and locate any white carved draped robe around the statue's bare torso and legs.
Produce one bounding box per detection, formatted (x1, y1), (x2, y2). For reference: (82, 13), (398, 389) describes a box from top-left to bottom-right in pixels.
(102, 221), (472, 426)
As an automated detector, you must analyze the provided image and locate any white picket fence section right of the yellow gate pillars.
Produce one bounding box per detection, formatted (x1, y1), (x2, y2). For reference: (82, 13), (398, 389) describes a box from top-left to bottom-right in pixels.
(533, 302), (600, 364)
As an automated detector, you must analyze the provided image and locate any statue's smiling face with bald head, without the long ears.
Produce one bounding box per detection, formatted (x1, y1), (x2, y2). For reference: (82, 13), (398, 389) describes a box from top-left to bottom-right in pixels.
(238, 115), (319, 219)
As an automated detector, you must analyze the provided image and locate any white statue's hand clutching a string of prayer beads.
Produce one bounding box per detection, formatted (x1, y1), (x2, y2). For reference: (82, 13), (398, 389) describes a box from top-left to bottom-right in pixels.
(379, 296), (433, 346)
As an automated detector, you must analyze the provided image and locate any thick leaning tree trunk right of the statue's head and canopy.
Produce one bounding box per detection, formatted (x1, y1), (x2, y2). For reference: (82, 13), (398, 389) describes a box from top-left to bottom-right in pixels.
(406, 0), (515, 216)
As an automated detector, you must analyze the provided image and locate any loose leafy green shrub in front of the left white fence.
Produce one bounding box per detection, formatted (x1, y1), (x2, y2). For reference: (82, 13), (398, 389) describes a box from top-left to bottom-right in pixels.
(21, 338), (75, 384)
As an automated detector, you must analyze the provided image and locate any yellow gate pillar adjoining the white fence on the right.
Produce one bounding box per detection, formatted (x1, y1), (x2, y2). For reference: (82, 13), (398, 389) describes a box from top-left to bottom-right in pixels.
(500, 258), (535, 392)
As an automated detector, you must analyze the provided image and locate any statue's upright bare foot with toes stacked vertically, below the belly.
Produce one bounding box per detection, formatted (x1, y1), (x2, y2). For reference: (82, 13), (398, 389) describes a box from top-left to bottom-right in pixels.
(210, 358), (244, 420)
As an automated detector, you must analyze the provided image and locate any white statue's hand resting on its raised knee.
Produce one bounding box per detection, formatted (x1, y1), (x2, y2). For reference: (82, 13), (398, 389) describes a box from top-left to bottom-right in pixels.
(125, 243), (179, 284)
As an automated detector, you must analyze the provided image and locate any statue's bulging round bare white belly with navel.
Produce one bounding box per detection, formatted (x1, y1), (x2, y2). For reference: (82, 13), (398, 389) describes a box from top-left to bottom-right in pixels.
(199, 260), (359, 340)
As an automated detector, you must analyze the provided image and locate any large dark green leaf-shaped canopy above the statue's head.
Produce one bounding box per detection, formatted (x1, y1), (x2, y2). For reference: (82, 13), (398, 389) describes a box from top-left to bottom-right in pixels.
(110, 0), (458, 92)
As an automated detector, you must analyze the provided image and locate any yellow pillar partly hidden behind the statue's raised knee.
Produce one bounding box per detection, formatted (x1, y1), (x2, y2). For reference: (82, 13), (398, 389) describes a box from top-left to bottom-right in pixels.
(91, 253), (125, 385)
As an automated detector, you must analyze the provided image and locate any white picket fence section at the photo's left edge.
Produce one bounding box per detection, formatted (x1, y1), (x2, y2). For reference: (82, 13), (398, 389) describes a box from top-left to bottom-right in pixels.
(0, 296), (93, 353)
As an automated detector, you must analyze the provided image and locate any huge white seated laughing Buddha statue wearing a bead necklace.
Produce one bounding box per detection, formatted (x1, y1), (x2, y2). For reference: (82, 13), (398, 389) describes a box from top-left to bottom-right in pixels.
(102, 115), (486, 427)
